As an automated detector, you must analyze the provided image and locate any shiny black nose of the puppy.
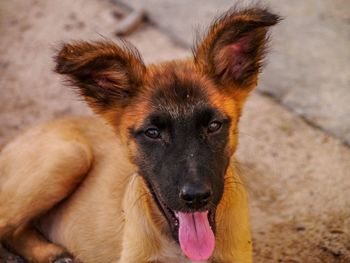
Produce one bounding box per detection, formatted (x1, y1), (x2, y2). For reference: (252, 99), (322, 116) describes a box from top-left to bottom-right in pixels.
(180, 184), (212, 208)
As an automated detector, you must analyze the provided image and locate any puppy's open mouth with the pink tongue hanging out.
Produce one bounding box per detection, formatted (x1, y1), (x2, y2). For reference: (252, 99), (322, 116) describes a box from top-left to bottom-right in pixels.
(148, 184), (215, 261)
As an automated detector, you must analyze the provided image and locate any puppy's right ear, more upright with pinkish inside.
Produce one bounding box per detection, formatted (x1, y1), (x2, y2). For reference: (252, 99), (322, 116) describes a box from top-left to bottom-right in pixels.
(193, 8), (280, 94)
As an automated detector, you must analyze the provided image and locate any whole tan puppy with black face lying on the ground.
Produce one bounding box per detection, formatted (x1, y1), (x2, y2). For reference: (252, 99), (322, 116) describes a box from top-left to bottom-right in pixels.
(0, 7), (280, 263)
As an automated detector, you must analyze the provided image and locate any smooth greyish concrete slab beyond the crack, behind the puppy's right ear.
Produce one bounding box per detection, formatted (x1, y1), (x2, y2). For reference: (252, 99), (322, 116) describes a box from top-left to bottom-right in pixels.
(115, 0), (350, 144)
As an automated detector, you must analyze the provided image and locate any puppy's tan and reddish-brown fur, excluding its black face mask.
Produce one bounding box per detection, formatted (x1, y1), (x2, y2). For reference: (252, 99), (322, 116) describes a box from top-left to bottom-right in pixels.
(0, 8), (278, 263)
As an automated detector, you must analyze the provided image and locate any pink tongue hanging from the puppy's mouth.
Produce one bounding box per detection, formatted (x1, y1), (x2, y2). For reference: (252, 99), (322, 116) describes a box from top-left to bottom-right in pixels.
(176, 211), (215, 261)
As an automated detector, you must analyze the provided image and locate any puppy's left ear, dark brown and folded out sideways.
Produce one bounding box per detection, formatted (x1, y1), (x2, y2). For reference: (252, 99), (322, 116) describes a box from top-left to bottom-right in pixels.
(55, 42), (146, 113)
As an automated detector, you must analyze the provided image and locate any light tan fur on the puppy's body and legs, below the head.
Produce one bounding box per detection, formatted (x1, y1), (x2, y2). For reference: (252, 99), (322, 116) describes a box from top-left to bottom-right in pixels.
(0, 118), (252, 263)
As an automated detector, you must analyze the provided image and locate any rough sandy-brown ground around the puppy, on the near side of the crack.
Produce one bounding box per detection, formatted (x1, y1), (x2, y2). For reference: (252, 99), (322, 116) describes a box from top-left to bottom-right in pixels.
(0, 0), (350, 263)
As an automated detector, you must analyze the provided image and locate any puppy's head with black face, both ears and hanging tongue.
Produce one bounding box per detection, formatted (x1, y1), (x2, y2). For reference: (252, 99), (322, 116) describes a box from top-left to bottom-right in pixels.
(56, 8), (279, 260)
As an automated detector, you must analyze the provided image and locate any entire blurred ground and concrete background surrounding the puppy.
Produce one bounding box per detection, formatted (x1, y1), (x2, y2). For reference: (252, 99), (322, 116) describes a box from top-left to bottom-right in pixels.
(0, 0), (350, 263)
